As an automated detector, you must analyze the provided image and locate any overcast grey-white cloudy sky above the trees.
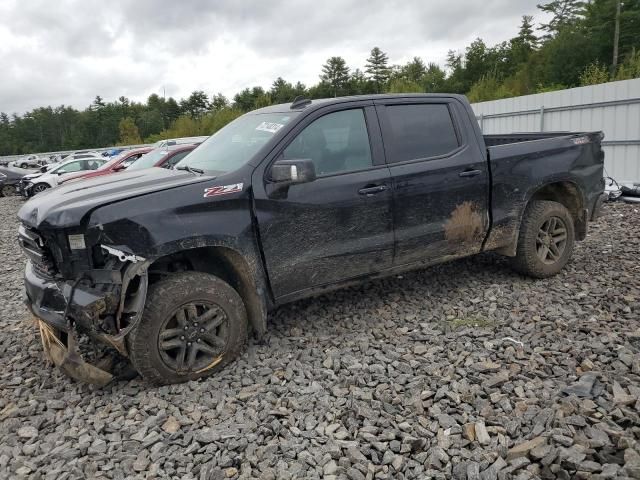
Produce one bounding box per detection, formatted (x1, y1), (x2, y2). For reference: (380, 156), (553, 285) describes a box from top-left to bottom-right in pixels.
(0, 0), (540, 113)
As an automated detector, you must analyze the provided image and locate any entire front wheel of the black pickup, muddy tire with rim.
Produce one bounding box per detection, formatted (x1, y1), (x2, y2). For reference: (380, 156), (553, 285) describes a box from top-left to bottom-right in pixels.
(127, 272), (247, 384)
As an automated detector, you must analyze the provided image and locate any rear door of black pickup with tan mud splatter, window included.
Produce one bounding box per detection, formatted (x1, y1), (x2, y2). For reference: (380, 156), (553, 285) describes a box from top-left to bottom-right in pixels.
(376, 97), (489, 266)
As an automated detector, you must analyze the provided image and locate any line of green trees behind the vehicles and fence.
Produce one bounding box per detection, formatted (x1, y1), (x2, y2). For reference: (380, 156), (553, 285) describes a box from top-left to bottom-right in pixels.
(0, 0), (640, 155)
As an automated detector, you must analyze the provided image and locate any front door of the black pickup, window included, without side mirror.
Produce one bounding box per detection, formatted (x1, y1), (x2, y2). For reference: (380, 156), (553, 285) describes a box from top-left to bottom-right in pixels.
(252, 101), (393, 299)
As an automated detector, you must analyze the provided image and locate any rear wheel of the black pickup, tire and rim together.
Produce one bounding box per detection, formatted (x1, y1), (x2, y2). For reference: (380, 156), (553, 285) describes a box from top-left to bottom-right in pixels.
(513, 200), (575, 278)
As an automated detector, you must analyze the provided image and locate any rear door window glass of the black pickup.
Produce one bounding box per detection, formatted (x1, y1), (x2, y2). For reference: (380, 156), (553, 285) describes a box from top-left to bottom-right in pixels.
(385, 104), (460, 163)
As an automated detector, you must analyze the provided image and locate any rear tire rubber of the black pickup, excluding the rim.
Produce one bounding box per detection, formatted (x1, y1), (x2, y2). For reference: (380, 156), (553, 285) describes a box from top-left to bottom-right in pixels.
(512, 200), (575, 278)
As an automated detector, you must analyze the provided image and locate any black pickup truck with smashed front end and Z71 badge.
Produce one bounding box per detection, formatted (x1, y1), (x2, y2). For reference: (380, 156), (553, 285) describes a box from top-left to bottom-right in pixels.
(19, 94), (604, 384)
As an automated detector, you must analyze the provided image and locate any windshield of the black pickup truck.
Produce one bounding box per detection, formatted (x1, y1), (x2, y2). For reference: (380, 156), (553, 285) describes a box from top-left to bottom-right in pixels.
(175, 112), (298, 175)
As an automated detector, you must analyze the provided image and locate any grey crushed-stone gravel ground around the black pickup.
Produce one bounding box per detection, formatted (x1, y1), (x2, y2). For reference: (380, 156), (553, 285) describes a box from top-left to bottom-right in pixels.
(0, 198), (640, 480)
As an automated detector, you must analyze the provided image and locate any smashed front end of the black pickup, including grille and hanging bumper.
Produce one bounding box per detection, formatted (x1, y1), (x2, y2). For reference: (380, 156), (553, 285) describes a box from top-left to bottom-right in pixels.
(19, 225), (151, 385)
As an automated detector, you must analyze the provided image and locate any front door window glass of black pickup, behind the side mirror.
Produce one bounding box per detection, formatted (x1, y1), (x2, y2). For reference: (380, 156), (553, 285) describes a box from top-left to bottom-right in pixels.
(281, 108), (373, 176)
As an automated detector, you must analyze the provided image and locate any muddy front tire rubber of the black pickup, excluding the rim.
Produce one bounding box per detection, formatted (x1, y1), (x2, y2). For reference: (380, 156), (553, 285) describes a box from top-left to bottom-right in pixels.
(127, 272), (247, 385)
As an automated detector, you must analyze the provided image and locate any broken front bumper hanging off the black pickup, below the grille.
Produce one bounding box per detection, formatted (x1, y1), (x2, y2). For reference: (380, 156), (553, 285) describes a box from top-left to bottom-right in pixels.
(24, 248), (149, 385)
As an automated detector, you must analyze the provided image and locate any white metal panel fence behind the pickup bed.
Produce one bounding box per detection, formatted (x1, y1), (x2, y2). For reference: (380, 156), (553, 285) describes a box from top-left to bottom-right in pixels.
(472, 79), (640, 183)
